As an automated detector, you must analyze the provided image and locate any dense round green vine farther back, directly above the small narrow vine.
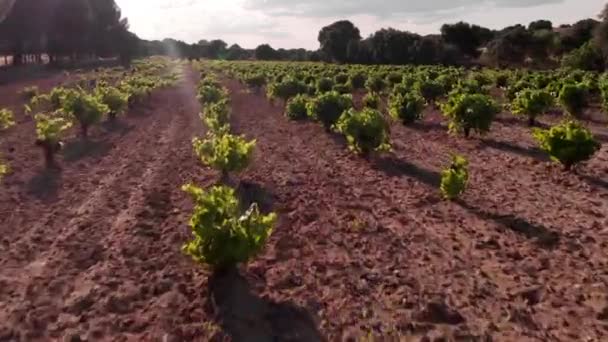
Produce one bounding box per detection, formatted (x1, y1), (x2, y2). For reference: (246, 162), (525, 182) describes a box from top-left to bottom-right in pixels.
(441, 94), (499, 137)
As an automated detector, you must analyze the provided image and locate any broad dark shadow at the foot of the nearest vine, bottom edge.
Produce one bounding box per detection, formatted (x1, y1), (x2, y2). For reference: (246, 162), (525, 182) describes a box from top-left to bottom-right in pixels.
(209, 269), (324, 342)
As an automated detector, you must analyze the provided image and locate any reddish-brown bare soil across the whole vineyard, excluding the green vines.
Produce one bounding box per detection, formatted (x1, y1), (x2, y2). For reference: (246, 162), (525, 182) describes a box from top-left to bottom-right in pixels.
(0, 57), (608, 341)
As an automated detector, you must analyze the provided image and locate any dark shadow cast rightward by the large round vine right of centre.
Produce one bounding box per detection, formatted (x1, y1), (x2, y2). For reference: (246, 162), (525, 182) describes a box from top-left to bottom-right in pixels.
(372, 156), (441, 188)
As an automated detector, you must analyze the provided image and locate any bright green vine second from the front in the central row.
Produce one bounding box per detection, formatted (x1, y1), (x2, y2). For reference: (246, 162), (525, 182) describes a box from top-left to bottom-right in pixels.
(192, 132), (255, 180)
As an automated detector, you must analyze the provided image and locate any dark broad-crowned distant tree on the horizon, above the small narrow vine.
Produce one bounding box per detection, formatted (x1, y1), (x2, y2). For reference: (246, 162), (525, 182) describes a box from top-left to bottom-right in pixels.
(441, 21), (494, 57)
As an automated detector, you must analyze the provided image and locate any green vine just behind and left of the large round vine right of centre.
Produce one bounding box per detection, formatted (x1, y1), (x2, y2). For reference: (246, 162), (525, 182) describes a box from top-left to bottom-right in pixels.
(306, 91), (353, 131)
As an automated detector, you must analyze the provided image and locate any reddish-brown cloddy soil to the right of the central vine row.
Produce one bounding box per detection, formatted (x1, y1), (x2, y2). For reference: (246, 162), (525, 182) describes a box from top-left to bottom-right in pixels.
(227, 81), (608, 341)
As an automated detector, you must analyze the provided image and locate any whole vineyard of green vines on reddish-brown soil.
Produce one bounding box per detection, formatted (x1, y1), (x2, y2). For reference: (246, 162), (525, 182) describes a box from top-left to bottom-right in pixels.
(0, 57), (608, 341)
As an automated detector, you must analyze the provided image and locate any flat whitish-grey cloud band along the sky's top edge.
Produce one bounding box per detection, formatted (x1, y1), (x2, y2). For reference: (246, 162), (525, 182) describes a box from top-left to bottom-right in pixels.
(244, 0), (564, 18)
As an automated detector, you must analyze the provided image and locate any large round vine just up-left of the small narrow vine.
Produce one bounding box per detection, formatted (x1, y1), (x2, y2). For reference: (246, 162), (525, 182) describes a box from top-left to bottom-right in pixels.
(336, 108), (390, 156)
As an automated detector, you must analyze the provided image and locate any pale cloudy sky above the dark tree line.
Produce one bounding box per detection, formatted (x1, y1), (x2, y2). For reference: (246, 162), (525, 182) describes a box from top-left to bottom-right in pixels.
(116, 0), (604, 49)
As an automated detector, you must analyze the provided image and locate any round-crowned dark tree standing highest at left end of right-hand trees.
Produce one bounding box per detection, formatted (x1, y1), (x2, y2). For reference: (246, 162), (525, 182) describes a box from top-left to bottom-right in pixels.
(318, 20), (361, 63)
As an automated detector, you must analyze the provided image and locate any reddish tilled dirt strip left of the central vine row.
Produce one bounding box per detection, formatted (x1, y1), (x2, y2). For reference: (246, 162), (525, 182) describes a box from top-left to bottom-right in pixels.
(0, 71), (217, 341)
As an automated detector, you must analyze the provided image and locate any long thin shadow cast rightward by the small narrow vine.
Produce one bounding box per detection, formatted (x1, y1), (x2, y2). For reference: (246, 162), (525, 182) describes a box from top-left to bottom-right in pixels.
(456, 200), (560, 249)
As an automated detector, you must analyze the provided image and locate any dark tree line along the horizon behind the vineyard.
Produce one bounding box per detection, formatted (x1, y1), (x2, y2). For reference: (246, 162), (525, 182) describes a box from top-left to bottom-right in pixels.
(0, 0), (608, 70)
